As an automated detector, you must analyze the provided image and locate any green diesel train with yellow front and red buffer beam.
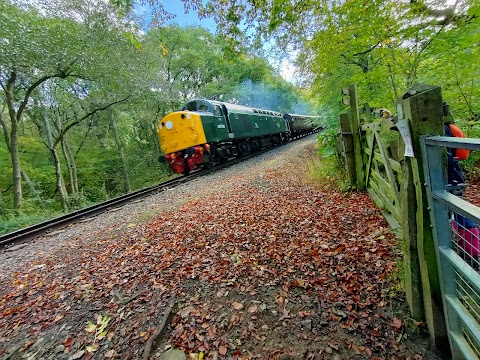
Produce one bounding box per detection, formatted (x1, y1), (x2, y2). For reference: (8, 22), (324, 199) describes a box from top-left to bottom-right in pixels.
(158, 99), (317, 174)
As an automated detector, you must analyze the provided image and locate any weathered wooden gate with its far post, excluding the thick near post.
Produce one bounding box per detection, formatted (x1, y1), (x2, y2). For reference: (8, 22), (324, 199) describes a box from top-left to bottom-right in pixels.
(339, 85), (403, 230)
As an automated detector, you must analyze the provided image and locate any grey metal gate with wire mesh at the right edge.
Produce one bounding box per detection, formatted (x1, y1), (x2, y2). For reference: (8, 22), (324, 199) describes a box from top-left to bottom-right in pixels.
(421, 136), (480, 360)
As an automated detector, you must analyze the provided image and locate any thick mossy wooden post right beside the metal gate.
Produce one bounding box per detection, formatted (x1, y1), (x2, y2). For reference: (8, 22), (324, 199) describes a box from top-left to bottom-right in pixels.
(397, 85), (448, 349)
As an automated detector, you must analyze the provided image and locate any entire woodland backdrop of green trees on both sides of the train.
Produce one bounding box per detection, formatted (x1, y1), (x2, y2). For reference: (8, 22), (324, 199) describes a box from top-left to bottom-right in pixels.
(0, 0), (480, 233)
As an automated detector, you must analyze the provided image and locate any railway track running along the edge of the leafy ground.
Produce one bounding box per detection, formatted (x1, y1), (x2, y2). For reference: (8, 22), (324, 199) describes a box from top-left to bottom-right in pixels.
(0, 131), (318, 251)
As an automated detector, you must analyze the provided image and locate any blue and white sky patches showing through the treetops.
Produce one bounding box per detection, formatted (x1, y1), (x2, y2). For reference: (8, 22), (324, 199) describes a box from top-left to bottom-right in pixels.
(136, 0), (296, 82)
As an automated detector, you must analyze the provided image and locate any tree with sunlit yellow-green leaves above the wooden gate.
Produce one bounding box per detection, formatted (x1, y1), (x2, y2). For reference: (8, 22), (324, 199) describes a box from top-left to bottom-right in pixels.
(158, 0), (480, 114)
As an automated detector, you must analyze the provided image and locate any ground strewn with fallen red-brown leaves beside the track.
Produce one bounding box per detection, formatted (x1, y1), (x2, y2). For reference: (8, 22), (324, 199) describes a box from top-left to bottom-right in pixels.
(0, 143), (434, 359)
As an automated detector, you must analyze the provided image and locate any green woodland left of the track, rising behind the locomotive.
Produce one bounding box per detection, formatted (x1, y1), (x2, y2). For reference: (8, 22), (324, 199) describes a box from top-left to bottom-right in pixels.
(0, 0), (318, 232)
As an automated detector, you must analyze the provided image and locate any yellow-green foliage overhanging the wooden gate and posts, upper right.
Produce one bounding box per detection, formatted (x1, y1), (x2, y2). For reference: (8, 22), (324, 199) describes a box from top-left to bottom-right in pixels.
(185, 0), (480, 125)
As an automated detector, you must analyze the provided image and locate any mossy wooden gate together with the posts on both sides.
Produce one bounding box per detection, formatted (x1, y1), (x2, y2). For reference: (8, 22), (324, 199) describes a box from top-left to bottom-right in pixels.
(339, 84), (456, 352)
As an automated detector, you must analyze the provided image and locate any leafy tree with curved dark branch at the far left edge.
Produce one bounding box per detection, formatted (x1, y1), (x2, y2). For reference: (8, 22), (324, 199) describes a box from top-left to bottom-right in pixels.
(0, 1), (141, 211)
